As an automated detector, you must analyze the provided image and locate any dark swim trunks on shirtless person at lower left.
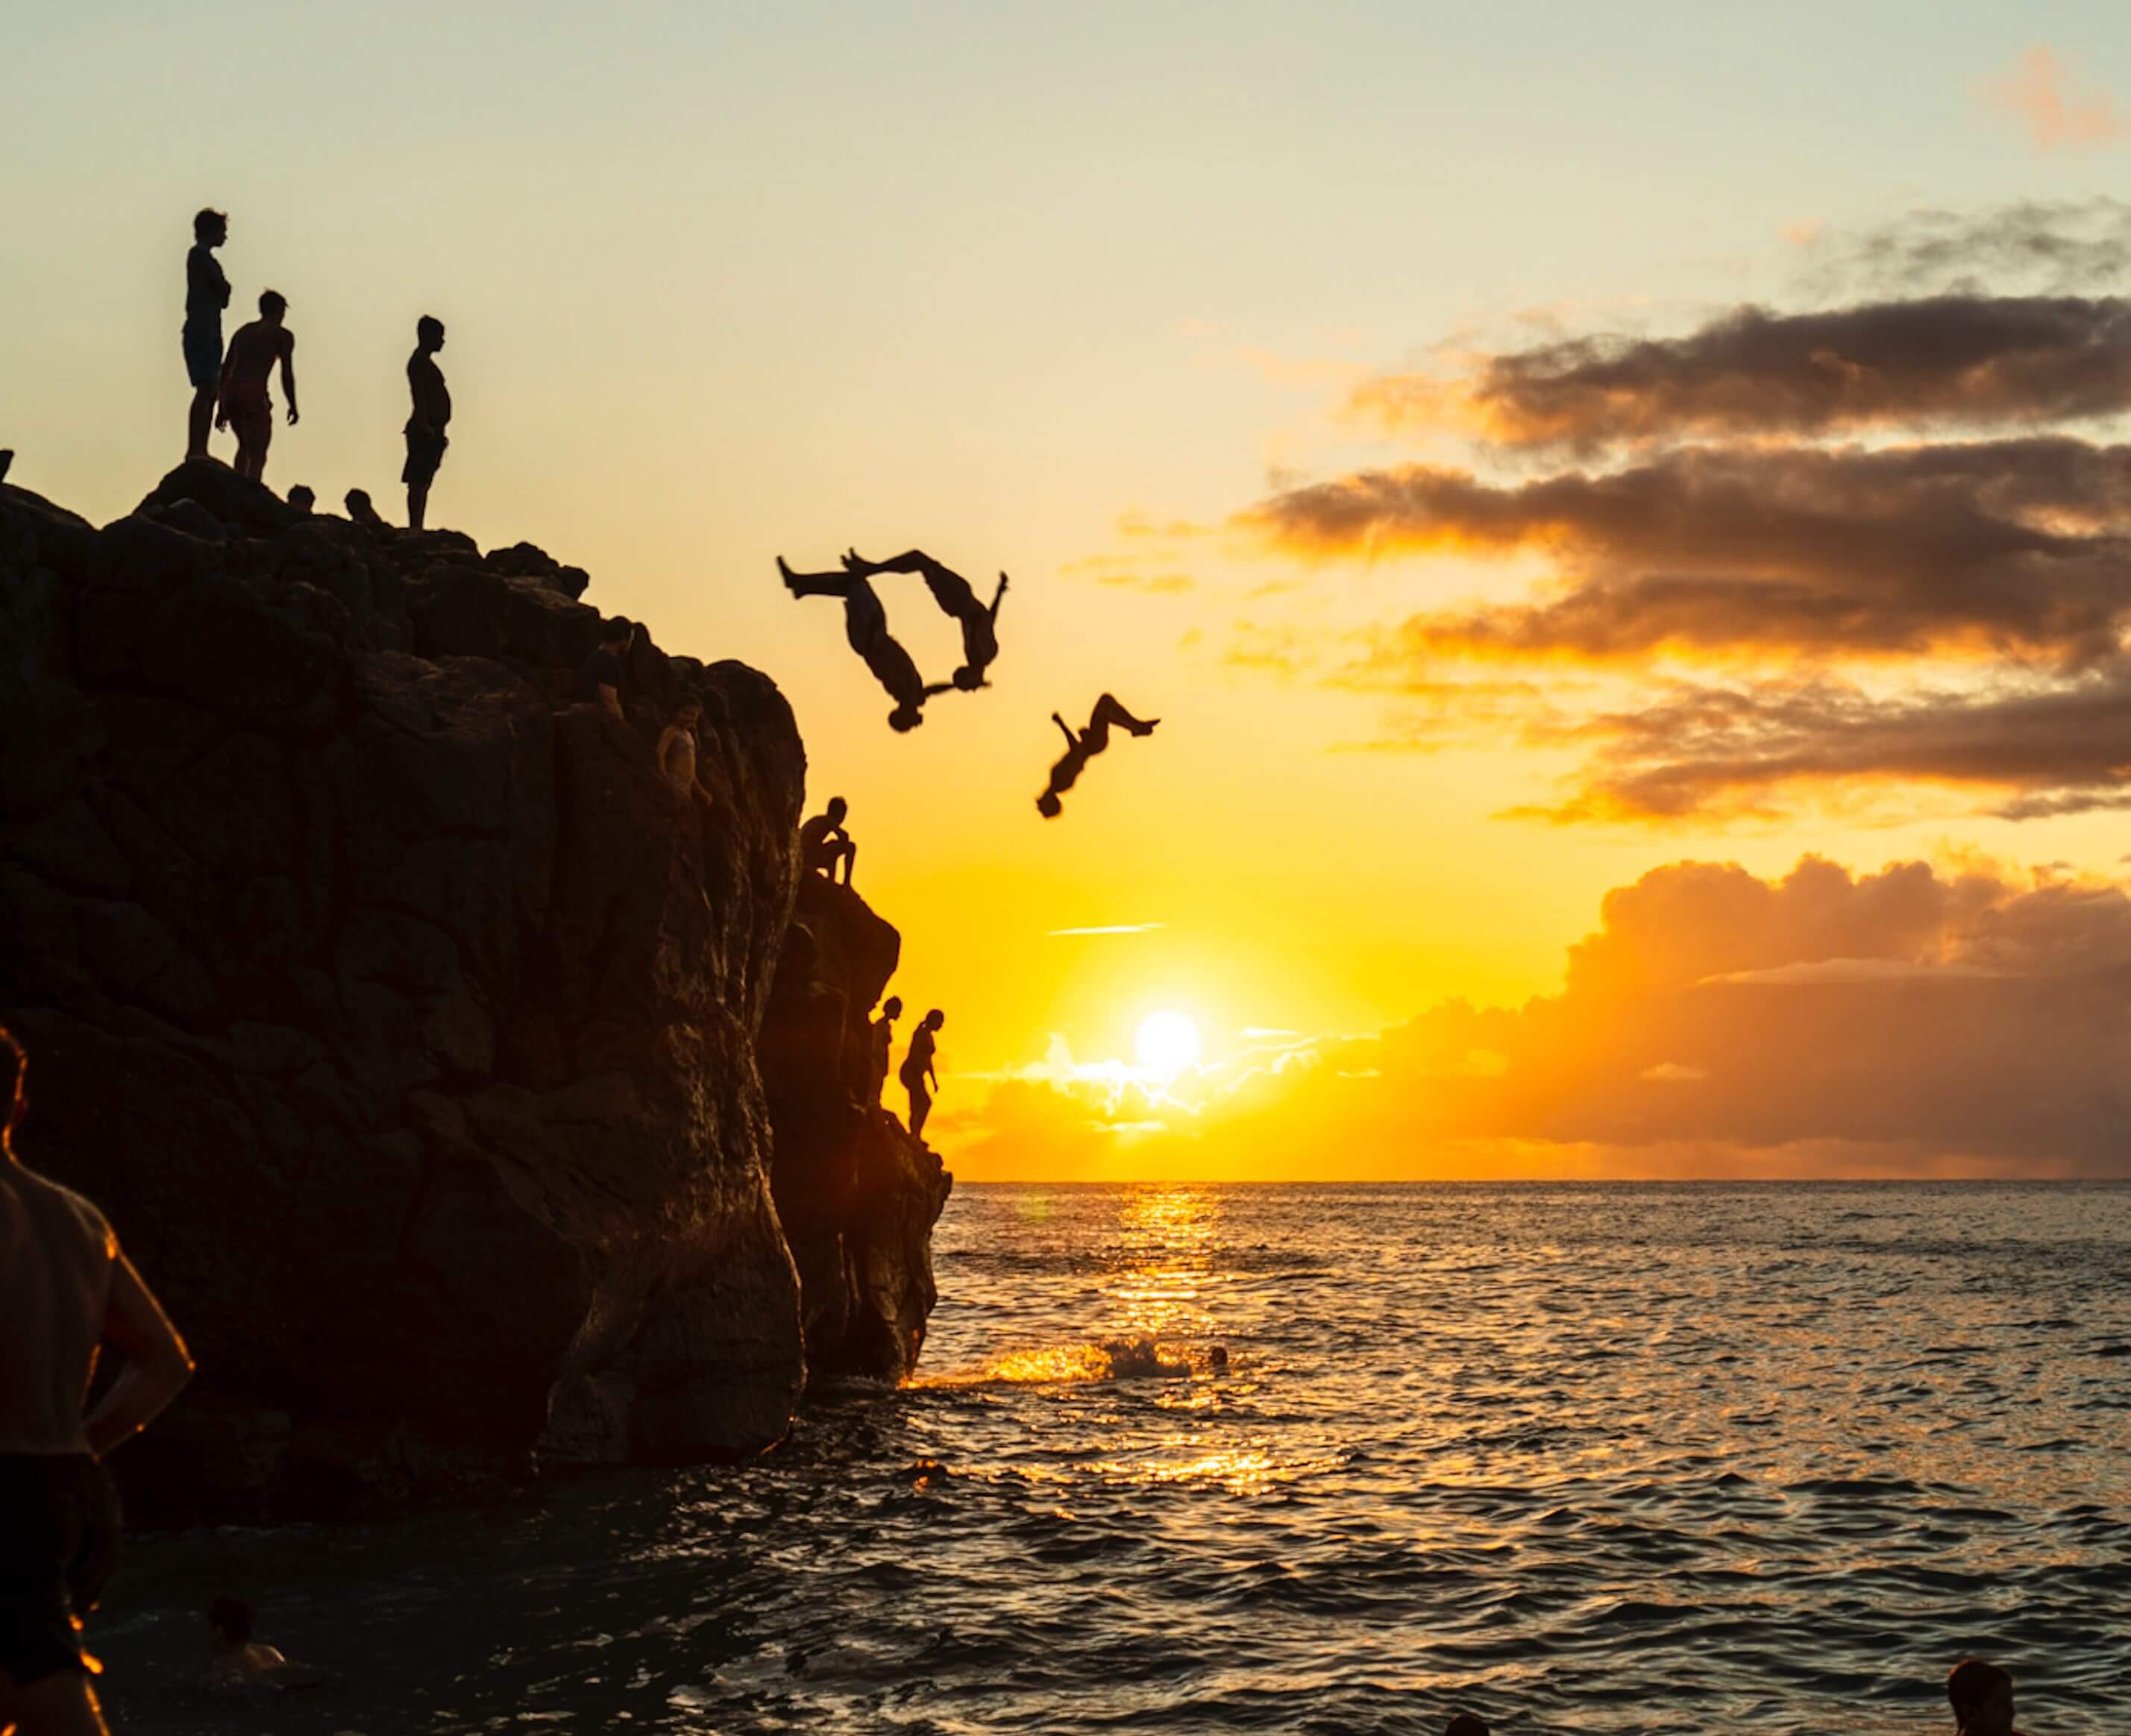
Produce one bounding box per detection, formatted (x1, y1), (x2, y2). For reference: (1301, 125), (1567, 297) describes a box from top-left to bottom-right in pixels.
(0, 1453), (119, 1687)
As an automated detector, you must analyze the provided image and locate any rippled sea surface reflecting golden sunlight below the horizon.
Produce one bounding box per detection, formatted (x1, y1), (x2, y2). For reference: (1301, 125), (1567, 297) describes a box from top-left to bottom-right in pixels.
(96, 1186), (2131, 1736)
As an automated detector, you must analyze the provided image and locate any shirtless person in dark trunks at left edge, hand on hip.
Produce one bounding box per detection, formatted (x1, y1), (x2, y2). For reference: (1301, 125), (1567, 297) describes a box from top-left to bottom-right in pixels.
(0, 1029), (192, 1736)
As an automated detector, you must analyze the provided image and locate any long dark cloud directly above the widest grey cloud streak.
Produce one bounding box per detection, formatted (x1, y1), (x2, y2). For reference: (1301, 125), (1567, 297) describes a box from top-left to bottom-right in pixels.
(1353, 296), (2131, 452)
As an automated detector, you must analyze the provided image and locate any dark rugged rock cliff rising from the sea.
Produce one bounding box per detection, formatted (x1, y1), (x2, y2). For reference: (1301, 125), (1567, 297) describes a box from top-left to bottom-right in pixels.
(0, 465), (947, 1519)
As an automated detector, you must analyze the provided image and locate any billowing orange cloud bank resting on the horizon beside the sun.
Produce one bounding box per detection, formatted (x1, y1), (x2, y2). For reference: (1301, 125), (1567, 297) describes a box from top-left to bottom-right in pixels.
(970, 856), (2131, 1176)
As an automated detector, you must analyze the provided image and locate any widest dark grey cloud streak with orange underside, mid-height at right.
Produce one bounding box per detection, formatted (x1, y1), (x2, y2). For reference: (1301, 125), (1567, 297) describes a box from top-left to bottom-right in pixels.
(1240, 438), (2131, 664)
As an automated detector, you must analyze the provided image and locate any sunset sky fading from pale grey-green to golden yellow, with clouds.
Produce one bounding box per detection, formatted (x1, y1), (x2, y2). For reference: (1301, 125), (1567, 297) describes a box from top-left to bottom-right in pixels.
(0, 0), (2131, 1180)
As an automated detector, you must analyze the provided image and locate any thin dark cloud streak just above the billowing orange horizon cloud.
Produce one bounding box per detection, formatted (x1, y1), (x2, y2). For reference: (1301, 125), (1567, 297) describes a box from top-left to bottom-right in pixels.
(1537, 660), (2131, 823)
